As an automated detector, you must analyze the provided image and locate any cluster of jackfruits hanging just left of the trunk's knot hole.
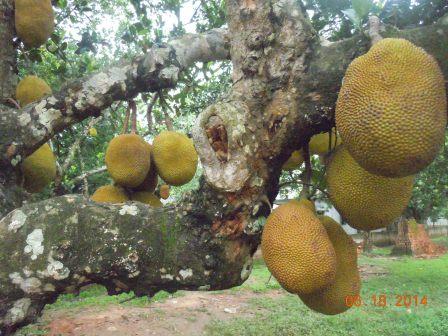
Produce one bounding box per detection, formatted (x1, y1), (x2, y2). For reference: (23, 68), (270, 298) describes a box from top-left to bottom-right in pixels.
(92, 131), (198, 207)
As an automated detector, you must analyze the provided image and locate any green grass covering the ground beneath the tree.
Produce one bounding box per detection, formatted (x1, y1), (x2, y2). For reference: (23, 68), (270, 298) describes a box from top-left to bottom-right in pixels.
(19, 237), (448, 336)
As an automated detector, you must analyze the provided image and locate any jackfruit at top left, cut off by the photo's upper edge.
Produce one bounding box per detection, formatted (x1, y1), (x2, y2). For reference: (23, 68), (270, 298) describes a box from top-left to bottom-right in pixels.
(15, 0), (54, 48)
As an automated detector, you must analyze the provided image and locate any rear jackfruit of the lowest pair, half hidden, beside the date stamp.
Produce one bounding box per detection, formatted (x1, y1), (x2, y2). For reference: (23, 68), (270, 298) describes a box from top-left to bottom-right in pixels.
(300, 216), (361, 315)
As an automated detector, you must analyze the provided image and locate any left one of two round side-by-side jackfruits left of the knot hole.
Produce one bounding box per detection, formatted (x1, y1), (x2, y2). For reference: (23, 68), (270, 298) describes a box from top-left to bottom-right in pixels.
(105, 134), (151, 187)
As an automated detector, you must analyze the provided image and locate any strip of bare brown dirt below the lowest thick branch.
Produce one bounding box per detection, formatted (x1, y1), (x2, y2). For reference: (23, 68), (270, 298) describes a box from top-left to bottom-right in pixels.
(43, 290), (284, 336)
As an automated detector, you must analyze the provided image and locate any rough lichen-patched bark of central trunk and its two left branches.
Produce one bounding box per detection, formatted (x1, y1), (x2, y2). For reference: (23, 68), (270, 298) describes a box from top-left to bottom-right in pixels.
(0, 0), (448, 333)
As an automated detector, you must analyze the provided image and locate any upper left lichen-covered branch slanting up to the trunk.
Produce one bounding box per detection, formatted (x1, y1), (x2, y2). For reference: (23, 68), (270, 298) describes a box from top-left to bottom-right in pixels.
(0, 29), (229, 165)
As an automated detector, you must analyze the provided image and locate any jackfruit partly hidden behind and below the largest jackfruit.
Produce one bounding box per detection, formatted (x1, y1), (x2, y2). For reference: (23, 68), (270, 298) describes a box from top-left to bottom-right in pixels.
(326, 145), (414, 231)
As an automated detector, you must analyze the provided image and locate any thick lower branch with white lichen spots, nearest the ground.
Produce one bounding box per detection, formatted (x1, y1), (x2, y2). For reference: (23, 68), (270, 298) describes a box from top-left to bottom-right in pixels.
(0, 195), (257, 334)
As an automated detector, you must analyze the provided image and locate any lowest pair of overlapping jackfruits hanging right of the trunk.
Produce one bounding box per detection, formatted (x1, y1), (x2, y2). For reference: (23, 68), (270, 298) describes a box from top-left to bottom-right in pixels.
(261, 199), (361, 315)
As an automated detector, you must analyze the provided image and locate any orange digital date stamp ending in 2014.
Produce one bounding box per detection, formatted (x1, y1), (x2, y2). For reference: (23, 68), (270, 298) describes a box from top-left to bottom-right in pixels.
(345, 294), (428, 308)
